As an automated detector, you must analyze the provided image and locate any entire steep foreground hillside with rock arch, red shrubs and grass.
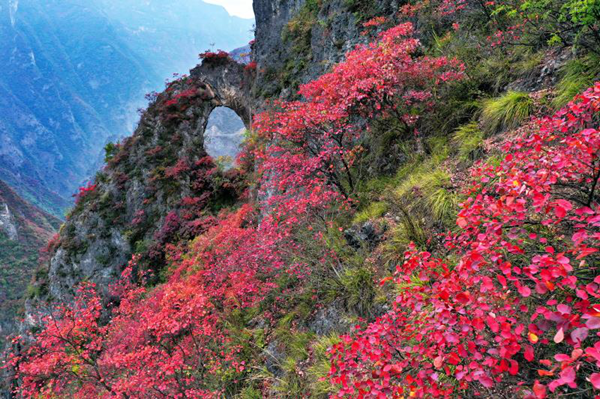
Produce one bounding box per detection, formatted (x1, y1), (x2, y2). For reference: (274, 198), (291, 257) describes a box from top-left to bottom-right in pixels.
(8, 0), (600, 399)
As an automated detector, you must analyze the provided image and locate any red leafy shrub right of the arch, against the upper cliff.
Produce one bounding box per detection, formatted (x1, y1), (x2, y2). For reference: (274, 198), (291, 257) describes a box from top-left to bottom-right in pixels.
(251, 23), (463, 203)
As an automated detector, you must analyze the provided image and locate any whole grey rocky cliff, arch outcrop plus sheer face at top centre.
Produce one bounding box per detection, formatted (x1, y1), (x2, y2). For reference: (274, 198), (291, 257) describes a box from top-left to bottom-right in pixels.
(27, 0), (397, 308)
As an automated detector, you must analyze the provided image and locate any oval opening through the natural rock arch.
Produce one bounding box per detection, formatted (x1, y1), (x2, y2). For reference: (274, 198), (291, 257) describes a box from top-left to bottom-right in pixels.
(204, 106), (246, 169)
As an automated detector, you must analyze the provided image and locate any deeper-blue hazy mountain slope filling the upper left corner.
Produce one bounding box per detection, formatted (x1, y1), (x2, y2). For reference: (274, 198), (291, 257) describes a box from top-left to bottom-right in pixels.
(0, 0), (158, 217)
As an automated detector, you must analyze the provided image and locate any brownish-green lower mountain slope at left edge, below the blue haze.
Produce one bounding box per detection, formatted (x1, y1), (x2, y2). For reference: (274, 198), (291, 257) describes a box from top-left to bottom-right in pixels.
(0, 181), (60, 338)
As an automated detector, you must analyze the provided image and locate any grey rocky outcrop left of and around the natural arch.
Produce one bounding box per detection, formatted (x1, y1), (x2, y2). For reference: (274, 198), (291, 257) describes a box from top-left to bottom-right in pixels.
(30, 59), (252, 306)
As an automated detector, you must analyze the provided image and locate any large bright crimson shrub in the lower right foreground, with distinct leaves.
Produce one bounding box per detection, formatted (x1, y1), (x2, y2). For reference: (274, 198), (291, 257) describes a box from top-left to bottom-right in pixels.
(330, 83), (600, 398)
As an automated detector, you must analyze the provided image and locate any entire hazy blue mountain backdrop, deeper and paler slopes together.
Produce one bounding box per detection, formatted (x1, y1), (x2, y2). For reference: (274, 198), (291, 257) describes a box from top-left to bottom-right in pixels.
(0, 0), (252, 215)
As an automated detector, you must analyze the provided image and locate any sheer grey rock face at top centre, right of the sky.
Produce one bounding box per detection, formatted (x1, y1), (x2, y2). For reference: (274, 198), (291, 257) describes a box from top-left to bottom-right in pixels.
(254, 0), (403, 98)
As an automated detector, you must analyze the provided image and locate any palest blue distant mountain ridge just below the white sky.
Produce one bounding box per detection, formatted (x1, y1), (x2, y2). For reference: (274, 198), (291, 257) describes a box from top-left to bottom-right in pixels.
(95, 0), (254, 76)
